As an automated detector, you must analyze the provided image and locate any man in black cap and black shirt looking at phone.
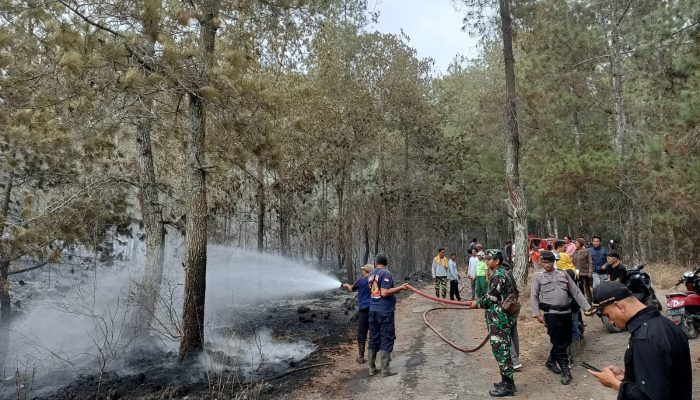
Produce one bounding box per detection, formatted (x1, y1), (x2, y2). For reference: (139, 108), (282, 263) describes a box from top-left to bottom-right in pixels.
(588, 281), (693, 400)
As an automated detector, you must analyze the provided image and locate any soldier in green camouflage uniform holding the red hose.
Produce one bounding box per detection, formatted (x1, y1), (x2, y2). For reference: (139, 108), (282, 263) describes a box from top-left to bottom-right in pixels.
(469, 250), (517, 397)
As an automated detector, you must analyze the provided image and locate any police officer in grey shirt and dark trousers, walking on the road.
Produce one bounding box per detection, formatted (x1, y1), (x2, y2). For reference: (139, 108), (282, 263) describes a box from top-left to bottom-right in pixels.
(530, 251), (591, 385)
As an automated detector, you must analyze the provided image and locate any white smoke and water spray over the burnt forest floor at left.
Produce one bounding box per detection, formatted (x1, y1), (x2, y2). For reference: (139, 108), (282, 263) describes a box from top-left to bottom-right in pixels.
(0, 241), (340, 397)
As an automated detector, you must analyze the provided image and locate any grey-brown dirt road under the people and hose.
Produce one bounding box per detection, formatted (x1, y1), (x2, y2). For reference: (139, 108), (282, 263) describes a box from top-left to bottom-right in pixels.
(290, 282), (700, 400)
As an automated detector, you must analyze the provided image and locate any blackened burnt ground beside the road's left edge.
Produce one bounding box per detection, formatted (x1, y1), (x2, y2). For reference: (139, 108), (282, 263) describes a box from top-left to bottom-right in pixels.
(5, 290), (364, 400)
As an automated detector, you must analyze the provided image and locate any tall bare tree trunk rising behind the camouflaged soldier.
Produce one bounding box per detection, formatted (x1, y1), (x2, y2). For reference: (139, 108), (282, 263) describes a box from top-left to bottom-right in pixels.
(499, 0), (528, 287)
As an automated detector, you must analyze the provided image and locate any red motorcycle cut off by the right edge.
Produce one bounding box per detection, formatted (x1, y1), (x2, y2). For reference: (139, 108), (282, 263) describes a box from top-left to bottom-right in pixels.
(666, 267), (700, 339)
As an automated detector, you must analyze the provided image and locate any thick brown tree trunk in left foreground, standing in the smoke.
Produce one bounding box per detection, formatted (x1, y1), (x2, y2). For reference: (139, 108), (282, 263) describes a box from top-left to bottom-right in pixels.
(180, 0), (219, 360)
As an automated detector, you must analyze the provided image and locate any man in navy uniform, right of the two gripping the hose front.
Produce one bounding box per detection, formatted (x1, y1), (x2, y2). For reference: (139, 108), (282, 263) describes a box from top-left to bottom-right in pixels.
(367, 254), (408, 377)
